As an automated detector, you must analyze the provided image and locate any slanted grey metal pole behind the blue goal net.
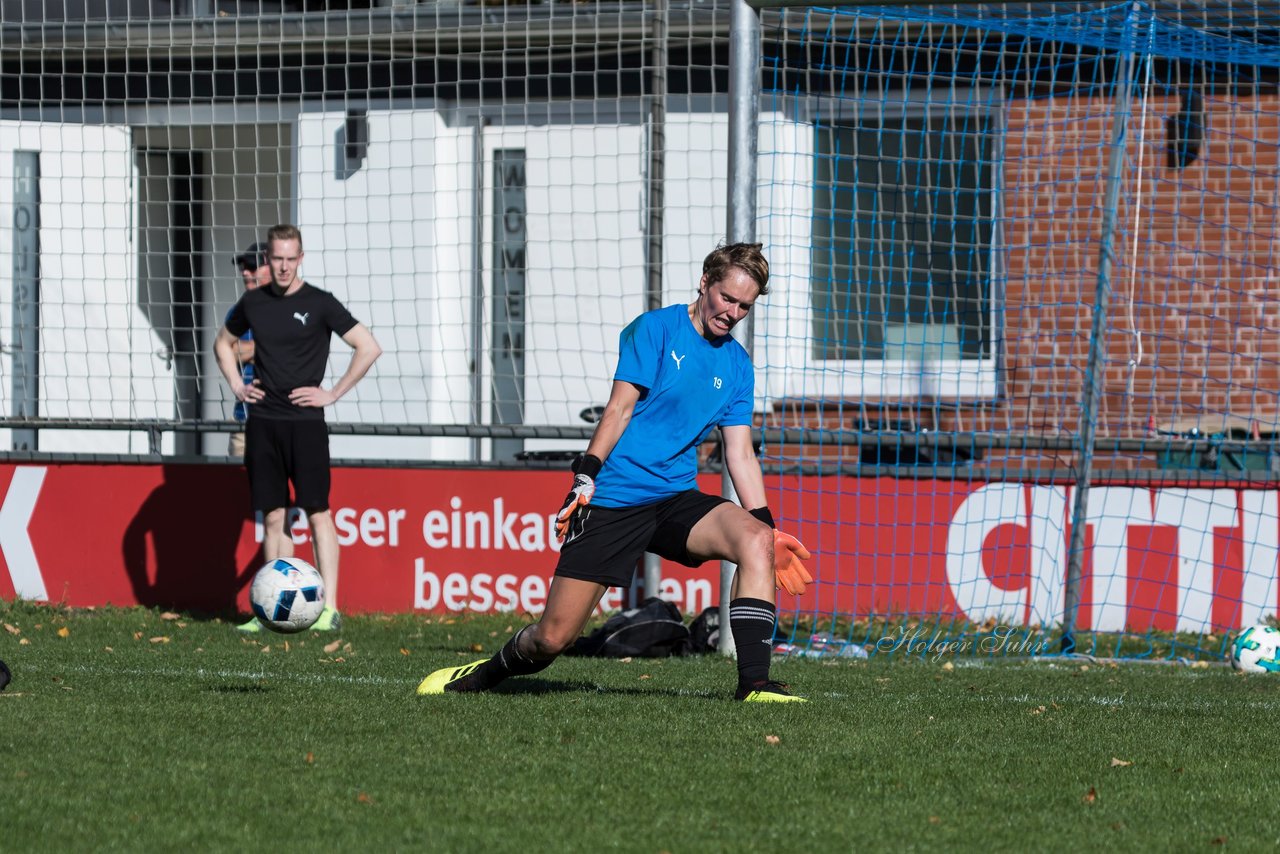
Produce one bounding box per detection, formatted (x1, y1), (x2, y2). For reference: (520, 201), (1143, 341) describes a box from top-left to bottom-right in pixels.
(1061, 3), (1139, 653)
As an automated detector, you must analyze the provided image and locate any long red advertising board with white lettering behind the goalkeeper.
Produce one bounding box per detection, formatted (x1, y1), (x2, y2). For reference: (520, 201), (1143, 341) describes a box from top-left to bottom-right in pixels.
(0, 463), (1280, 631)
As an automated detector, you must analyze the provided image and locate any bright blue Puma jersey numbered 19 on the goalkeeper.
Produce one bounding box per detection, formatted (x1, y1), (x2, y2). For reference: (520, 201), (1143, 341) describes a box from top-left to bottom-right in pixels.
(591, 305), (755, 507)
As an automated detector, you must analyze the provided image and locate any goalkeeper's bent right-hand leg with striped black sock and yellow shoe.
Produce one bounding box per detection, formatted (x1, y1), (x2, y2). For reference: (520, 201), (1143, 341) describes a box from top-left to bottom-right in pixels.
(686, 504), (800, 703)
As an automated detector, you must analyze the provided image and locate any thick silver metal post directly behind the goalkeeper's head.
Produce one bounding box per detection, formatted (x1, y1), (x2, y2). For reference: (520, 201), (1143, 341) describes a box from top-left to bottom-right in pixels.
(719, 0), (760, 656)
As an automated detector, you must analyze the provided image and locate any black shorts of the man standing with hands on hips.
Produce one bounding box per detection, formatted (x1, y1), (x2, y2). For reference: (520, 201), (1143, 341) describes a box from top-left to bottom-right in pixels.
(244, 416), (329, 513)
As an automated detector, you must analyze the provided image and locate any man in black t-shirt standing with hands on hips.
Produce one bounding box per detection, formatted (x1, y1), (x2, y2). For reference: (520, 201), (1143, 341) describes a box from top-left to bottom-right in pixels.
(214, 225), (383, 631)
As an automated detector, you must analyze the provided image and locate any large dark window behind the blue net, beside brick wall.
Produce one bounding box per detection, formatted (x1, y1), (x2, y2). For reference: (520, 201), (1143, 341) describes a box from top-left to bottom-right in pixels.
(809, 91), (1001, 396)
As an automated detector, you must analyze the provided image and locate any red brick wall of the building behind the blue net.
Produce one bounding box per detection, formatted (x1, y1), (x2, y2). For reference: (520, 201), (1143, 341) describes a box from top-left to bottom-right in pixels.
(778, 95), (1280, 467)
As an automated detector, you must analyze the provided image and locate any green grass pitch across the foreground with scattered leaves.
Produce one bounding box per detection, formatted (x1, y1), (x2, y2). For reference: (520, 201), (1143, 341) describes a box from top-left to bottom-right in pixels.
(0, 603), (1280, 853)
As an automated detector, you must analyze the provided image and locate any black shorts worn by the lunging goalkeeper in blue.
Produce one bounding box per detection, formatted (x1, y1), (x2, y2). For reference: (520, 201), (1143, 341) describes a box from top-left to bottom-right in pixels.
(556, 489), (728, 588)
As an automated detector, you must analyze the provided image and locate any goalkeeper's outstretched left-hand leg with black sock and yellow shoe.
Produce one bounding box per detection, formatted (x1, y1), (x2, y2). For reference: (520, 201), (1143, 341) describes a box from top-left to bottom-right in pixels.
(417, 576), (607, 694)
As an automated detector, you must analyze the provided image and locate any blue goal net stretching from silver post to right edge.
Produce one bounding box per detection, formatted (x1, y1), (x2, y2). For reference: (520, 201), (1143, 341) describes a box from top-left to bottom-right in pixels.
(751, 1), (1280, 656)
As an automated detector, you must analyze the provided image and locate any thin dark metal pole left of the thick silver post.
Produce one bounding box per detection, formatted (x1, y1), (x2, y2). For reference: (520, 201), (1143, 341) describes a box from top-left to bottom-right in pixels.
(644, 0), (667, 597)
